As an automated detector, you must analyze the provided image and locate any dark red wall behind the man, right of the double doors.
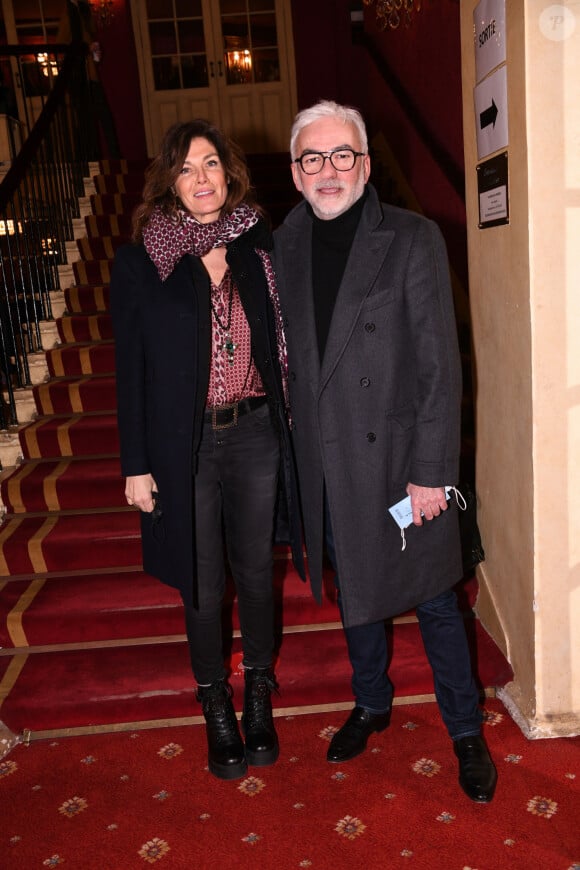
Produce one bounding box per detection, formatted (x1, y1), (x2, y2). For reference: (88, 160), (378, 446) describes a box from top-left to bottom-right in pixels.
(292, 0), (467, 283)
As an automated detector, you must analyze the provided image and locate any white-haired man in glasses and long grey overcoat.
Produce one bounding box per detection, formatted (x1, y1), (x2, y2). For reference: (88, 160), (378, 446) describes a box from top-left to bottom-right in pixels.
(275, 101), (497, 802)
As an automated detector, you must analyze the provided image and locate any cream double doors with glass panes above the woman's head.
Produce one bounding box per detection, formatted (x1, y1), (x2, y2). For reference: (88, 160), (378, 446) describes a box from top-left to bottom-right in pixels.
(131, 0), (296, 156)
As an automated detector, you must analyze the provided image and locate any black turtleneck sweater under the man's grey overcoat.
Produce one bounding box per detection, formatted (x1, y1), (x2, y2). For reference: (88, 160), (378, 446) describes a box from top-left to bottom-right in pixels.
(307, 187), (367, 362)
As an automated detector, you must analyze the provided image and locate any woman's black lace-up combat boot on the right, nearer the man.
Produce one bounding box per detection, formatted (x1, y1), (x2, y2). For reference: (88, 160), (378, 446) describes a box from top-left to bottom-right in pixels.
(242, 668), (280, 767)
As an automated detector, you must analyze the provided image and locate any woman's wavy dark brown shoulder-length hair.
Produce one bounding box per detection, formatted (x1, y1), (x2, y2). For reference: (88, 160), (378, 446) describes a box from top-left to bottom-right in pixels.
(133, 118), (260, 242)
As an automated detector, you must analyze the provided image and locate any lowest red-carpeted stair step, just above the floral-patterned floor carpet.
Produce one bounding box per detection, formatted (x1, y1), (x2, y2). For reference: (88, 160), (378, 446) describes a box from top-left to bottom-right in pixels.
(0, 623), (510, 733)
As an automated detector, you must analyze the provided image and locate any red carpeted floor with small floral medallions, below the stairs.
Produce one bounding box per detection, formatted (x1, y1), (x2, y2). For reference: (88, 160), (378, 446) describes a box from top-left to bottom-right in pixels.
(0, 701), (580, 870)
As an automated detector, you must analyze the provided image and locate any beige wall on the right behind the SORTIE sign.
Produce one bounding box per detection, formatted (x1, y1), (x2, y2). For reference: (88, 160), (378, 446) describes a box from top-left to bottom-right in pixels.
(461, 0), (580, 737)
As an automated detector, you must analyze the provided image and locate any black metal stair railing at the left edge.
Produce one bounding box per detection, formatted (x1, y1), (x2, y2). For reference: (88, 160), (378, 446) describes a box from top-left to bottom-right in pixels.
(0, 44), (98, 429)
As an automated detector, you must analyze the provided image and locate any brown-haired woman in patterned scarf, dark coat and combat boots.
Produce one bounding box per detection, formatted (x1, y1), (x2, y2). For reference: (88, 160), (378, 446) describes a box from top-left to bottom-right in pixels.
(111, 120), (303, 779)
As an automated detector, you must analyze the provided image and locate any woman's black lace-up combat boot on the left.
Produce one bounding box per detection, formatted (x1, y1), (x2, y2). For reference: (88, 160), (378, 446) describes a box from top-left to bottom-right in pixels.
(197, 680), (248, 779)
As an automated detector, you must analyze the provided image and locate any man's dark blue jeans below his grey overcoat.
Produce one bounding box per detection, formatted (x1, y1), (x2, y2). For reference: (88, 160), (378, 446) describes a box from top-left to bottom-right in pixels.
(325, 500), (481, 740)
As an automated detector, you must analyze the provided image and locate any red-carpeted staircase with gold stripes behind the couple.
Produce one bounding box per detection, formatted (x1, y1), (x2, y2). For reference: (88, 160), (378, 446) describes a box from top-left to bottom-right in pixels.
(0, 155), (511, 739)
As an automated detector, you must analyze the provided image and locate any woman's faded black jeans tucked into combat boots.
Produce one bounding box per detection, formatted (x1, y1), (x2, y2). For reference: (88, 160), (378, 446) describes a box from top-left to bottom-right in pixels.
(185, 404), (279, 685)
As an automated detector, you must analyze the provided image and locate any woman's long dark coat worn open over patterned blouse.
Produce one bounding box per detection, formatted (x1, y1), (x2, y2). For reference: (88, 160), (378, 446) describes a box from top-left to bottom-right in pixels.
(111, 222), (304, 605)
